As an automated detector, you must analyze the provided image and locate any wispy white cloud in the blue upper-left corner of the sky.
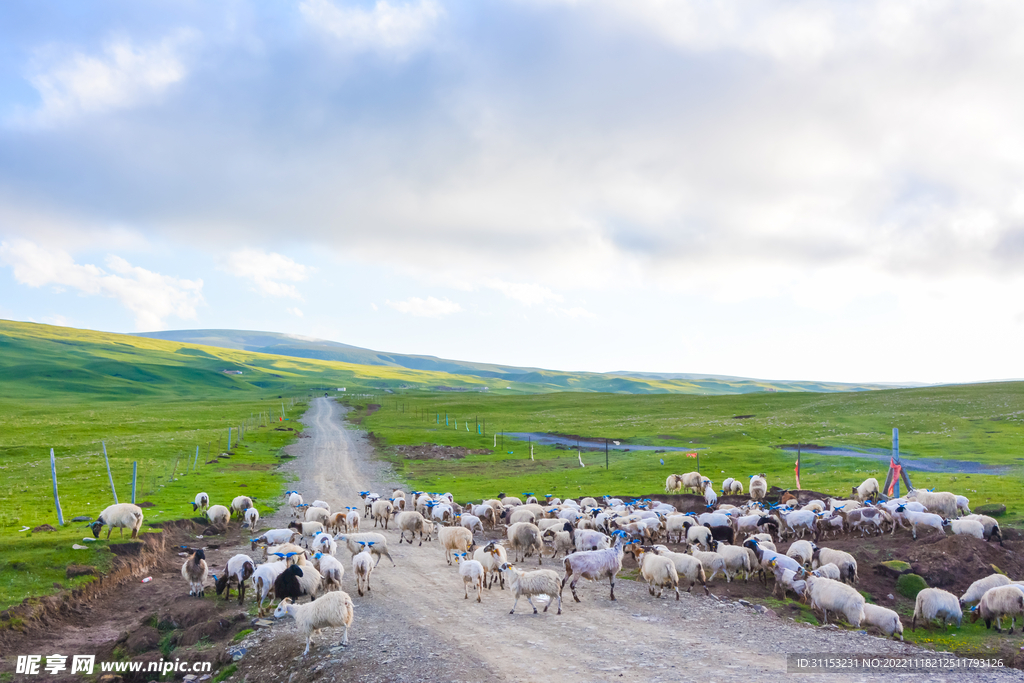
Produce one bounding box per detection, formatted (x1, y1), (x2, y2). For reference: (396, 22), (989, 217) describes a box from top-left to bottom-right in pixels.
(29, 32), (191, 123)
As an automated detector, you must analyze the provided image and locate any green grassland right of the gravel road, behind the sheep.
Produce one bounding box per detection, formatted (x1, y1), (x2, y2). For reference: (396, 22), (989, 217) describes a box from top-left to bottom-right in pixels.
(350, 382), (1024, 522)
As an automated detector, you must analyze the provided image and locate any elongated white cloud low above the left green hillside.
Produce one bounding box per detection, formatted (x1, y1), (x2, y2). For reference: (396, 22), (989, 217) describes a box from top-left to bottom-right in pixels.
(0, 240), (203, 330)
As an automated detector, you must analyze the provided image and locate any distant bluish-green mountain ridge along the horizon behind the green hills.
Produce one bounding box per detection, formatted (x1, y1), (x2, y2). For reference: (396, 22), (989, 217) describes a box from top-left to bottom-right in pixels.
(133, 330), (905, 394)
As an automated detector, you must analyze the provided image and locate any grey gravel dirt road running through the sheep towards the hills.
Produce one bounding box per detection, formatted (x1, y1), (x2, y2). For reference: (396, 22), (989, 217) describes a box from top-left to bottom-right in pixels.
(240, 398), (1022, 683)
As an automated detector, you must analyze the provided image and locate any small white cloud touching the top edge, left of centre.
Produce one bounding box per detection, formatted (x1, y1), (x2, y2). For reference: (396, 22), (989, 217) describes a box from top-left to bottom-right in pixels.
(300, 0), (442, 53)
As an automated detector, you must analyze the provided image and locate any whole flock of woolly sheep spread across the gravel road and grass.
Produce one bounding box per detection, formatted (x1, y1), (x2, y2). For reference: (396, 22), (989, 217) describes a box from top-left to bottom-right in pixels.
(93, 472), (1024, 654)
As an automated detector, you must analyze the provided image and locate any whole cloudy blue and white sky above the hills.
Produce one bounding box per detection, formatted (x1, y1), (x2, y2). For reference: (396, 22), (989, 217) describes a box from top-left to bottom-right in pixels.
(0, 0), (1024, 383)
